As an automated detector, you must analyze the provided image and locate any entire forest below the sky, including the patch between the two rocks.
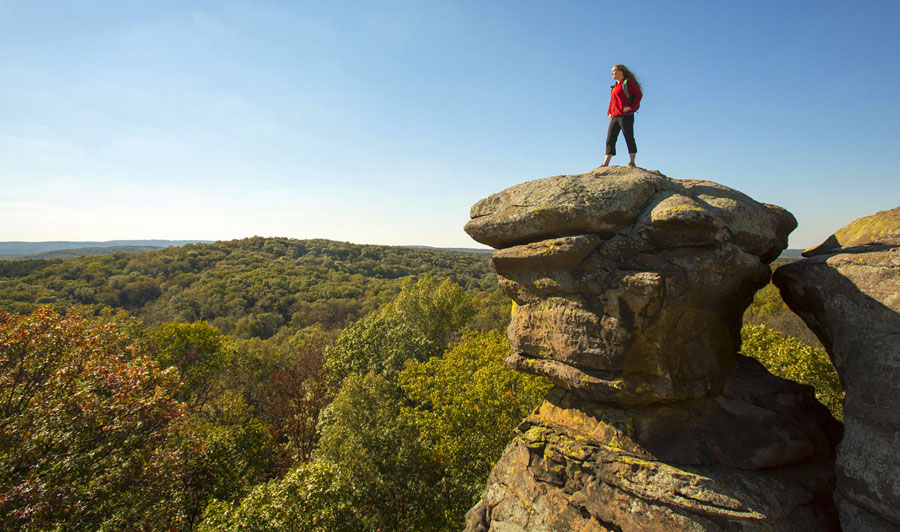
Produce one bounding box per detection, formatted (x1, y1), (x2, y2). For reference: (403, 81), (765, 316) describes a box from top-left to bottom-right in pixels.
(0, 237), (841, 531)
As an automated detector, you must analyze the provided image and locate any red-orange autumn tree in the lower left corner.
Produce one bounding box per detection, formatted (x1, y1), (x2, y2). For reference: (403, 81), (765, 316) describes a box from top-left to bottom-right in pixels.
(0, 307), (184, 530)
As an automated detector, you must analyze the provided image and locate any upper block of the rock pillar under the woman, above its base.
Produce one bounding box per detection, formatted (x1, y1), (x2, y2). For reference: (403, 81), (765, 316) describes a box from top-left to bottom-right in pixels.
(465, 167), (797, 404)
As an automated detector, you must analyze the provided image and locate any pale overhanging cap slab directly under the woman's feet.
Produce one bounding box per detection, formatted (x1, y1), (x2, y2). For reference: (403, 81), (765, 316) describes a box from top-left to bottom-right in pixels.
(465, 166), (797, 261)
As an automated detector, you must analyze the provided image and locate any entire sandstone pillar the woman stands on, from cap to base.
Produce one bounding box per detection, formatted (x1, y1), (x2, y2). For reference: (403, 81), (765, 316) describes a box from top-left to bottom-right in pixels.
(466, 167), (839, 531)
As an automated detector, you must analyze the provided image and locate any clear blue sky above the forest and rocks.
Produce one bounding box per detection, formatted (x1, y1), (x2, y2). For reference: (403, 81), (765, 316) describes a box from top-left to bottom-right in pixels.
(0, 0), (900, 248)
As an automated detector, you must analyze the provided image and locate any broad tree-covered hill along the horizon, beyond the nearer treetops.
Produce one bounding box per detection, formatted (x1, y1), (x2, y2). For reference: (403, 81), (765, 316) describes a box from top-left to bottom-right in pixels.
(0, 237), (498, 338)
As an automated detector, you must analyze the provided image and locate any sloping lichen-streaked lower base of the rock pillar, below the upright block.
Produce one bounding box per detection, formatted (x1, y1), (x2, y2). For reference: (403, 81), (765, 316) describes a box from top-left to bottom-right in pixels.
(466, 366), (837, 532)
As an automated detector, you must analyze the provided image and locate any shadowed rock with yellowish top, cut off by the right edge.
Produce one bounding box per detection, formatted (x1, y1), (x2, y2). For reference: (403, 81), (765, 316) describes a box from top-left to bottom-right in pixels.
(773, 207), (900, 531)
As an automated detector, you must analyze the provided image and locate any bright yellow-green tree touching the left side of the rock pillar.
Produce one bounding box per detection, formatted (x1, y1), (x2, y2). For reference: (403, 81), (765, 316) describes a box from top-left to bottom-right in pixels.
(400, 331), (551, 530)
